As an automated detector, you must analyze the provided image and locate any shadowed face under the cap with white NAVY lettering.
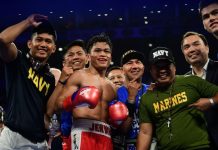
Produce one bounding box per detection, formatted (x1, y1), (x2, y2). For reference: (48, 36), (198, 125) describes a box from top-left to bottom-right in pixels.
(150, 60), (176, 86)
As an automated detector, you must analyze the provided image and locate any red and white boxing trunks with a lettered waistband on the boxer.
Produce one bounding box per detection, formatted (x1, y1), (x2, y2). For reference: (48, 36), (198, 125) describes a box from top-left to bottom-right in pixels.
(71, 119), (113, 150)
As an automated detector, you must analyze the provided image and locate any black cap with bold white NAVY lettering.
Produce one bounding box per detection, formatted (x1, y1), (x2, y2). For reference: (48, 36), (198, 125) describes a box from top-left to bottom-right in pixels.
(148, 47), (175, 65)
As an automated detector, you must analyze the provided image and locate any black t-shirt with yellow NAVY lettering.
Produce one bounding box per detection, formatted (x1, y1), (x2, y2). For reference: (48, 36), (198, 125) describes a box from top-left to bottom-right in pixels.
(4, 51), (55, 142)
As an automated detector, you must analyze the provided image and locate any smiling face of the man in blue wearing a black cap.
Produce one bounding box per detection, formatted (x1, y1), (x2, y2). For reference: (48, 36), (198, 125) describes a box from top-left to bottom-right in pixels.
(123, 59), (145, 81)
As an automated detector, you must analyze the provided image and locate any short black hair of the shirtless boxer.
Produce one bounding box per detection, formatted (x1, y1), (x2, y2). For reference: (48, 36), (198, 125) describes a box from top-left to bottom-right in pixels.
(87, 33), (112, 53)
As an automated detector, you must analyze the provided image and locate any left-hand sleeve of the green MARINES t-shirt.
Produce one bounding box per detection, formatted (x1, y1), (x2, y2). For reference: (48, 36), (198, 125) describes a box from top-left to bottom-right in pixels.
(139, 94), (152, 123)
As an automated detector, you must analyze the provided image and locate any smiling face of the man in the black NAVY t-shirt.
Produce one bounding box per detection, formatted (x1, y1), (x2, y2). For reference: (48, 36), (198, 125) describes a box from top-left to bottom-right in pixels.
(27, 33), (56, 61)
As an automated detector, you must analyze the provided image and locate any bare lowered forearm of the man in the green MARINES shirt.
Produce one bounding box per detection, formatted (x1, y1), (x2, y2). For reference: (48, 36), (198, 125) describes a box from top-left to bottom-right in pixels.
(137, 123), (153, 150)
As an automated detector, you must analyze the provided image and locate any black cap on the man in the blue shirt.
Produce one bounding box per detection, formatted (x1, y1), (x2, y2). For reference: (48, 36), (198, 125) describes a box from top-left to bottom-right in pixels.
(121, 50), (145, 66)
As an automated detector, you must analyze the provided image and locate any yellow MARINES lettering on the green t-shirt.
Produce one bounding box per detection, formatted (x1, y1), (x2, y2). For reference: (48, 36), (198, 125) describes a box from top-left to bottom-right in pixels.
(153, 92), (187, 113)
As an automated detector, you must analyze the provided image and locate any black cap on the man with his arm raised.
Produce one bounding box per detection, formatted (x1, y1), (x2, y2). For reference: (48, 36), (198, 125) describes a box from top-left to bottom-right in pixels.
(32, 20), (57, 41)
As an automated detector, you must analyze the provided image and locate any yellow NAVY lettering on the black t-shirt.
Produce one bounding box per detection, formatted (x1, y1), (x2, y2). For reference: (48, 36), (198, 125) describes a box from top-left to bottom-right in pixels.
(28, 67), (50, 96)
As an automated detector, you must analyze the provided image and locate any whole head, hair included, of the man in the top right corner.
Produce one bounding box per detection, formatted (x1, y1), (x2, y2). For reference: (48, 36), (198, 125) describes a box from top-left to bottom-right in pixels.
(199, 0), (218, 40)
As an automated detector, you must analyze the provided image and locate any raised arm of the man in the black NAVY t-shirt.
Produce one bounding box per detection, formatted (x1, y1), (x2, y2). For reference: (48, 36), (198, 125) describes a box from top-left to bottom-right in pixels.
(0, 14), (47, 62)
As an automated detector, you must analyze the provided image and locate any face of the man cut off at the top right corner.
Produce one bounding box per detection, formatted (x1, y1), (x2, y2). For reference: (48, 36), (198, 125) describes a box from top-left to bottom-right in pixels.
(201, 3), (218, 35)
